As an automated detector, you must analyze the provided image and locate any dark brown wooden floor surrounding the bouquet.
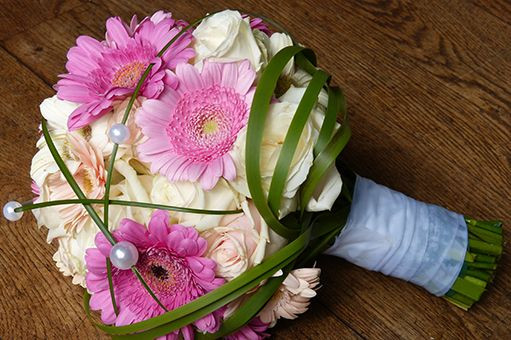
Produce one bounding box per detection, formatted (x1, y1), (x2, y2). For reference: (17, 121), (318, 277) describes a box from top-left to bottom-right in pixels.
(0, 0), (511, 339)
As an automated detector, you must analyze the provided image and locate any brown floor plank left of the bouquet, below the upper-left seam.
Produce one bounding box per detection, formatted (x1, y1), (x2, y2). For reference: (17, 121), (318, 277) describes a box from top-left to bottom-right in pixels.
(0, 49), (97, 339)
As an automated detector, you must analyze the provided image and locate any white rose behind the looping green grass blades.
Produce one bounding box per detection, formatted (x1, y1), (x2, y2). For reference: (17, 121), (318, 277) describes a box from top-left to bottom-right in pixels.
(232, 86), (342, 218)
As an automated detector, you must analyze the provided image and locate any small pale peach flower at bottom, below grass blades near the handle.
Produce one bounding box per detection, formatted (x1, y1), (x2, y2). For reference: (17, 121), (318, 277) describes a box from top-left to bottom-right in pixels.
(259, 268), (321, 327)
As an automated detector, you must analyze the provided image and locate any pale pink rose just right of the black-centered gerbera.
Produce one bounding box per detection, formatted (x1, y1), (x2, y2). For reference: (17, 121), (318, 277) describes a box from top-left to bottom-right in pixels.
(202, 202), (268, 280)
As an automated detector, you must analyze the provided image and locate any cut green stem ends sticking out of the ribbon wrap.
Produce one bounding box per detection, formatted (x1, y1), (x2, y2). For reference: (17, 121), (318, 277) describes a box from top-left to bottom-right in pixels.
(444, 217), (503, 310)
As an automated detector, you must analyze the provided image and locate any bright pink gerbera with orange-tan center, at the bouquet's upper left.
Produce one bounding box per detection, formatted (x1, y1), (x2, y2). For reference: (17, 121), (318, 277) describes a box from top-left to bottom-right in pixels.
(55, 11), (194, 130)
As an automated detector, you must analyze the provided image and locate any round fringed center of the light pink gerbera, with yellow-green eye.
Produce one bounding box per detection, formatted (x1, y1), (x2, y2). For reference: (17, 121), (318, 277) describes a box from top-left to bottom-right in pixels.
(167, 85), (248, 162)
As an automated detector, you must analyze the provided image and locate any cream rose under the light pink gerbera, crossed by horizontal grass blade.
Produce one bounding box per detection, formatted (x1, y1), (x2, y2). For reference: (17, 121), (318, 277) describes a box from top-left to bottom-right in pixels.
(150, 175), (240, 231)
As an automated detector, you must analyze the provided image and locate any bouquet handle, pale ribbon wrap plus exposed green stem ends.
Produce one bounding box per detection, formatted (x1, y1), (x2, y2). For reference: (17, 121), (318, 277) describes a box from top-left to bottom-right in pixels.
(325, 176), (502, 309)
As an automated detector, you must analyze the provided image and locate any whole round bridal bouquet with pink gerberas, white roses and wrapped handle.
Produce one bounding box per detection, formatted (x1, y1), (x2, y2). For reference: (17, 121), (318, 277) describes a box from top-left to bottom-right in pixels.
(4, 10), (502, 339)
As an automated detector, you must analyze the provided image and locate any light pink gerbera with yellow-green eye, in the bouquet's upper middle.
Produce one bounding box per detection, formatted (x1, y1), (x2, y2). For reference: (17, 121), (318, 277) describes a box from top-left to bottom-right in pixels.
(136, 60), (256, 190)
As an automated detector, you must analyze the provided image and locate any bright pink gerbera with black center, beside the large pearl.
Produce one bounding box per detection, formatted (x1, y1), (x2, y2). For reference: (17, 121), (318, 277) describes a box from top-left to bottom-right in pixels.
(85, 211), (224, 339)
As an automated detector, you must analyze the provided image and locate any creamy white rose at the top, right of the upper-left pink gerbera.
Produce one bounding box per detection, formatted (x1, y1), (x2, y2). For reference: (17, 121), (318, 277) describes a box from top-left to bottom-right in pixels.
(193, 10), (262, 71)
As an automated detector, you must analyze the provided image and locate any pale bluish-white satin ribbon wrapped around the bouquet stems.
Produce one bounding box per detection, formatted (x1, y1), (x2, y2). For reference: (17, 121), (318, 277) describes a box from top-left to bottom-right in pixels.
(325, 176), (468, 296)
